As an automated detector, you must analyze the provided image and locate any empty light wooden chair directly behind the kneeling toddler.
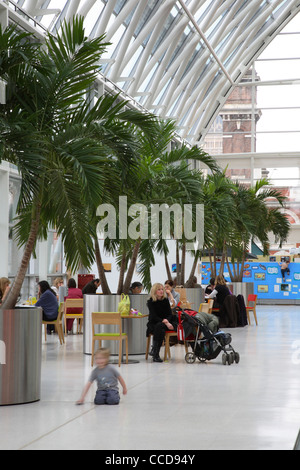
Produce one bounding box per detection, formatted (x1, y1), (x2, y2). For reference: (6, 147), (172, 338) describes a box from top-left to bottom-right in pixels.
(92, 312), (128, 367)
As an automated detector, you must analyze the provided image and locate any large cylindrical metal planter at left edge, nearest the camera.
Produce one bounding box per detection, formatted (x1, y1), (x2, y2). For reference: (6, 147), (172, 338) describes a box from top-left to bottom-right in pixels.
(0, 308), (42, 405)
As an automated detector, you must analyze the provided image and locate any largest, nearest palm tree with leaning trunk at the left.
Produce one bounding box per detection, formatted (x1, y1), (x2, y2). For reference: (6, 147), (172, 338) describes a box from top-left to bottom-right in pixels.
(0, 18), (151, 308)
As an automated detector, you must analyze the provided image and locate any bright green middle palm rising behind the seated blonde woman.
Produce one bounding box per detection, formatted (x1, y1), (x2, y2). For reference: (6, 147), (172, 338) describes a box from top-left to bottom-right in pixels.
(118, 120), (218, 290)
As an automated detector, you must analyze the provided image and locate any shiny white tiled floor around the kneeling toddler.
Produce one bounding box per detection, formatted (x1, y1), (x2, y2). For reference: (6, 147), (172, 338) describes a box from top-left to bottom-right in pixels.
(0, 305), (300, 450)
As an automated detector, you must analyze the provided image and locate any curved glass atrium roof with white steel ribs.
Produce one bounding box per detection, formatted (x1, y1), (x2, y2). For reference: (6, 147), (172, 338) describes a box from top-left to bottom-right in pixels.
(5, 0), (300, 144)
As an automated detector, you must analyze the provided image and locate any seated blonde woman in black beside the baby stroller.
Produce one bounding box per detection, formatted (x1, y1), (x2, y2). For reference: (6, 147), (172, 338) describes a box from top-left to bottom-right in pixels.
(146, 283), (176, 362)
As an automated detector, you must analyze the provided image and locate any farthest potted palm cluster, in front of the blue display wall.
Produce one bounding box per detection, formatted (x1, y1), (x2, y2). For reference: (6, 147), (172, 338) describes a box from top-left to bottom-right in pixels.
(200, 172), (290, 292)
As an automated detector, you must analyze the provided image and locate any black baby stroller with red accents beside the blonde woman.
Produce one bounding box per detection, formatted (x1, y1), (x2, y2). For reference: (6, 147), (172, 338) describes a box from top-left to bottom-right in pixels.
(180, 311), (240, 365)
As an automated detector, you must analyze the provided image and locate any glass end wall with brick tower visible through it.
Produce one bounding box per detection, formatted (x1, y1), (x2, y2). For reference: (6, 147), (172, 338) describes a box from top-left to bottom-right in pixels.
(204, 15), (300, 252)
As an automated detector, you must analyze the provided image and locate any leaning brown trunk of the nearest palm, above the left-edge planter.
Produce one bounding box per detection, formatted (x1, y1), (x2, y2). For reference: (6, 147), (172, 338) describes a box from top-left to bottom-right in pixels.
(1, 204), (41, 310)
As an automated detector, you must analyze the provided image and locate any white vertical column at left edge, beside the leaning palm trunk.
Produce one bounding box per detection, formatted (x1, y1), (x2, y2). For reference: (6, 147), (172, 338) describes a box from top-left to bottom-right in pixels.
(0, 162), (9, 277)
